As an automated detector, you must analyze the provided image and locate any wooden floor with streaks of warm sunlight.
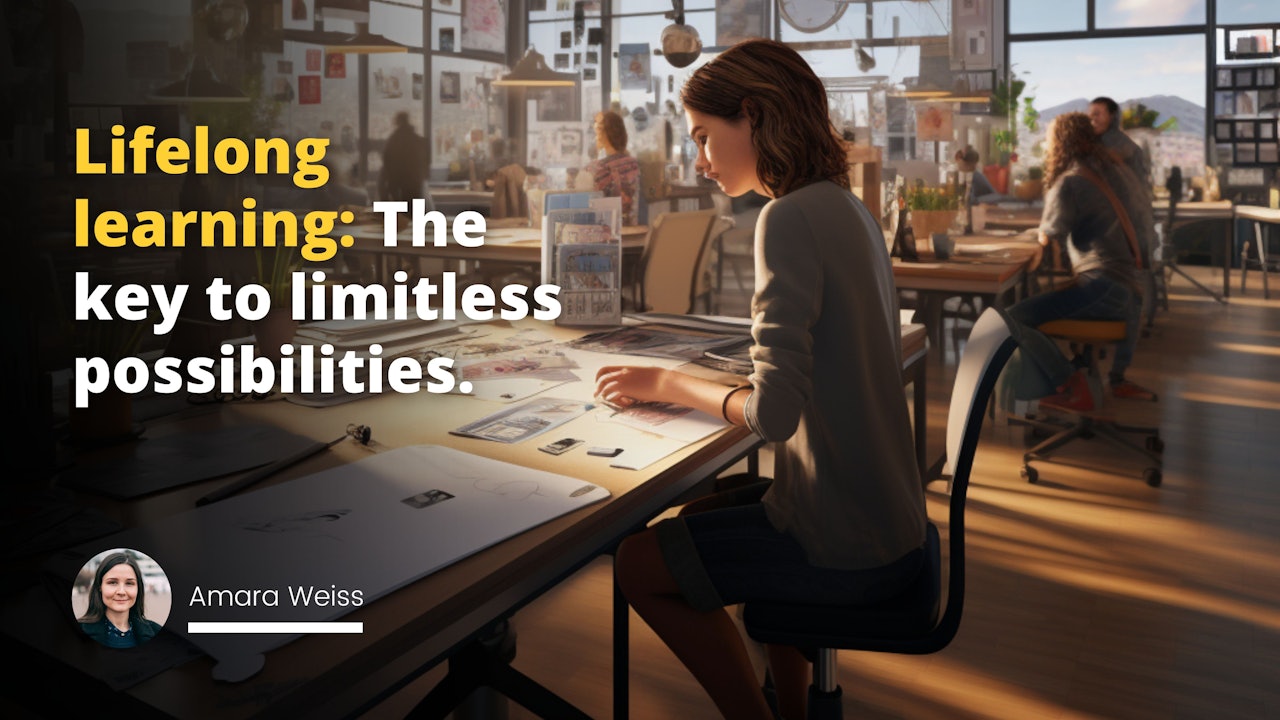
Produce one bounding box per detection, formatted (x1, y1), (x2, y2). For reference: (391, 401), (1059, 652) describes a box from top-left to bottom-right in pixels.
(370, 268), (1280, 720)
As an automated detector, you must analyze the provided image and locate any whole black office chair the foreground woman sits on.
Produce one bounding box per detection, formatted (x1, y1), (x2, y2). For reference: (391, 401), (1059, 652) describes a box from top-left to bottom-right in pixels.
(742, 309), (1015, 720)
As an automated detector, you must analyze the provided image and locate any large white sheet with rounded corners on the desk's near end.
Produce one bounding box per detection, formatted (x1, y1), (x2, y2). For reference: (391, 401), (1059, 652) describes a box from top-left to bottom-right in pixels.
(46, 446), (609, 662)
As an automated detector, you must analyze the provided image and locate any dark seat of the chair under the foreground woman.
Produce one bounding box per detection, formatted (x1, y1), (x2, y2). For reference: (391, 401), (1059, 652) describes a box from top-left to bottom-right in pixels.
(742, 523), (942, 650)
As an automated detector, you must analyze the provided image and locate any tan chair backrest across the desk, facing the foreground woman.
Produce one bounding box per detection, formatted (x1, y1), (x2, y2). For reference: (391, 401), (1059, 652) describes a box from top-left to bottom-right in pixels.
(640, 208), (718, 315)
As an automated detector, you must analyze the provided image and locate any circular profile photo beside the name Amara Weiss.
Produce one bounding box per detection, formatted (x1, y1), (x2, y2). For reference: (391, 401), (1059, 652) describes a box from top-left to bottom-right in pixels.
(72, 547), (173, 648)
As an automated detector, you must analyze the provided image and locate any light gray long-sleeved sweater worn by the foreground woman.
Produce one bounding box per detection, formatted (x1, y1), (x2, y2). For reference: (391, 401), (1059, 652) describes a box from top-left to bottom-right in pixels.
(745, 182), (925, 570)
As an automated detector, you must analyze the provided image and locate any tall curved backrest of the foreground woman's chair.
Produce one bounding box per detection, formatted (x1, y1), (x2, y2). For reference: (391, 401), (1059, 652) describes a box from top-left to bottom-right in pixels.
(932, 307), (1016, 644)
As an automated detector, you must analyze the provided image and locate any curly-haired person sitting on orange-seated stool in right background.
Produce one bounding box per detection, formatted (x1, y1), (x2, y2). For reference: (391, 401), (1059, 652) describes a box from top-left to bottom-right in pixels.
(1005, 113), (1146, 411)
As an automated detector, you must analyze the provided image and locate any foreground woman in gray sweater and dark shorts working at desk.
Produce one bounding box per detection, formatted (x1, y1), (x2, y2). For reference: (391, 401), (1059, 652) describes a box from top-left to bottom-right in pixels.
(596, 40), (925, 719)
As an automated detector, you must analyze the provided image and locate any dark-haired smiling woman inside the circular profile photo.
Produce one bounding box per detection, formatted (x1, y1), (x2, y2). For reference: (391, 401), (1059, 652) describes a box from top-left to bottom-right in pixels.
(78, 552), (160, 647)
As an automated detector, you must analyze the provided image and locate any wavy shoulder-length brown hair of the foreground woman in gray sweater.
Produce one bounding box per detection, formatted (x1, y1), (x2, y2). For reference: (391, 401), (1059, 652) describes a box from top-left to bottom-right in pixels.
(680, 40), (849, 197)
